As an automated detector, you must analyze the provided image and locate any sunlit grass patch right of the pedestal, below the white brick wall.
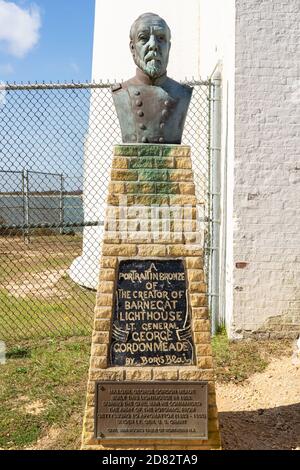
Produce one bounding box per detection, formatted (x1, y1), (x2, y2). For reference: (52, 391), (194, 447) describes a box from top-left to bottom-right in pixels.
(212, 330), (292, 383)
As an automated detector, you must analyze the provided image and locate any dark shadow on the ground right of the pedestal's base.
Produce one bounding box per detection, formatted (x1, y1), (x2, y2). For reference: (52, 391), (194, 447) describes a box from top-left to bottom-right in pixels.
(219, 402), (300, 450)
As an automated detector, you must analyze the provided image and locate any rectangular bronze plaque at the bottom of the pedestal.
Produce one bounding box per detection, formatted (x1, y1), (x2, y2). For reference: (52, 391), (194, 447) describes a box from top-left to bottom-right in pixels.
(95, 381), (208, 440)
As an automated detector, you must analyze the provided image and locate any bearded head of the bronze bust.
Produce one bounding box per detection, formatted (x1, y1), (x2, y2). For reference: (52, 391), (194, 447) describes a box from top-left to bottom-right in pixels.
(130, 13), (171, 79)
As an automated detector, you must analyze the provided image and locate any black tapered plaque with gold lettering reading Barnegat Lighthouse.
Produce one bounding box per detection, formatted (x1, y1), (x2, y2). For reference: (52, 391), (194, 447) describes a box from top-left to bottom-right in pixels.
(109, 259), (195, 367)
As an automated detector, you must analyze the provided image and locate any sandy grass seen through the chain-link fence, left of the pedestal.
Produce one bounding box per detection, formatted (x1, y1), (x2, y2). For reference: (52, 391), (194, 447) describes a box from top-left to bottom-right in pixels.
(0, 235), (95, 344)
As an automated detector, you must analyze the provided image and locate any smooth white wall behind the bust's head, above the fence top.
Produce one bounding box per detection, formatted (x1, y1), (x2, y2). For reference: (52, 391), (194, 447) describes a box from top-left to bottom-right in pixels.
(92, 0), (200, 81)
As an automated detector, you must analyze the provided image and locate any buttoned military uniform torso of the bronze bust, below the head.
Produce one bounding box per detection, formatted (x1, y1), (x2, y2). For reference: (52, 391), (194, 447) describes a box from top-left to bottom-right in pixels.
(112, 69), (193, 144)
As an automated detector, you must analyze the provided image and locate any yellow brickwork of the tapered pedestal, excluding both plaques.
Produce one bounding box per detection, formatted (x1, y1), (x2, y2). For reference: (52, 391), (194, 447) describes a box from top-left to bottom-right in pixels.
(82, 145), (220, 450)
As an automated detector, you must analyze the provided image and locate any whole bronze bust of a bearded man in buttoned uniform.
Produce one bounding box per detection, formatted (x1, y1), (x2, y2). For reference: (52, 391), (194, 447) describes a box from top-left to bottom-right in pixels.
(112, 13), (193, 144)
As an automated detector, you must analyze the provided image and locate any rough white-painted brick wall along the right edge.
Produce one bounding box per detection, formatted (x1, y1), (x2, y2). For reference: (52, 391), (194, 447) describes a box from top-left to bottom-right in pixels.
(233, 0), (300, 336)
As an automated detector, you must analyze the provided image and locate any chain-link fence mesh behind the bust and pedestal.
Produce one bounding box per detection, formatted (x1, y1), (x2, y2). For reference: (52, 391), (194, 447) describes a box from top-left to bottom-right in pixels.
(0, 82), (211, 342)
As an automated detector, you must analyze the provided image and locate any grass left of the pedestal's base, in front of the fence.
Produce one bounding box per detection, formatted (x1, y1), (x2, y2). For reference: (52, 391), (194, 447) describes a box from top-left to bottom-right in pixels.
(0, 338), (90, 449)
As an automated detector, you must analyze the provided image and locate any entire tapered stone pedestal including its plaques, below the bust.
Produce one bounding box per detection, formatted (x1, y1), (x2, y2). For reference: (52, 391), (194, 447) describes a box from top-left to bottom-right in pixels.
(82, 144), (220, 450)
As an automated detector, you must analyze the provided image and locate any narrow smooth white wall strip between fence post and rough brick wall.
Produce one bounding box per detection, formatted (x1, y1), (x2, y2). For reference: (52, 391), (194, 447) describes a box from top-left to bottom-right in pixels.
(200, 0), (235, 334)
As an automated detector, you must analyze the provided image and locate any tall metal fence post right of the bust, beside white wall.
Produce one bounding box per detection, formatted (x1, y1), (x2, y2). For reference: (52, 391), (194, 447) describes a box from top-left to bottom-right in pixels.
(210, 71), (222, 335)
